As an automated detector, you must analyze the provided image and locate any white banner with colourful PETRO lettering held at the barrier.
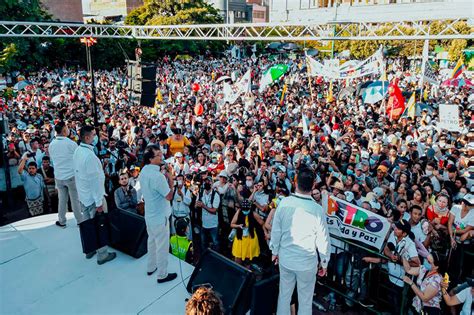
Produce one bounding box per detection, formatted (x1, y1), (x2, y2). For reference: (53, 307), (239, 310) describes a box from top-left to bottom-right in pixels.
(323, 194), (390, 250)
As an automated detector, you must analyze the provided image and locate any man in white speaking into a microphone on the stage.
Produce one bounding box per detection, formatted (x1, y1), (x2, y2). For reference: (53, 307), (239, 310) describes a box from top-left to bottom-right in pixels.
(138, 145), (177, 283)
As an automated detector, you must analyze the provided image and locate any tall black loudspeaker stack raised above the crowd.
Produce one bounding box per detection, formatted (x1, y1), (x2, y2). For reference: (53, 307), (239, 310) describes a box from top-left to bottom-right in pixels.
(127, 62), (156, 107)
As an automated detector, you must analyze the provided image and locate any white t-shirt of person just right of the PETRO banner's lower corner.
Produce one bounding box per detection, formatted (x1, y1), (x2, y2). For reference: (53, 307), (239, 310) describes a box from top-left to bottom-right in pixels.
(388, 232), (418, 287)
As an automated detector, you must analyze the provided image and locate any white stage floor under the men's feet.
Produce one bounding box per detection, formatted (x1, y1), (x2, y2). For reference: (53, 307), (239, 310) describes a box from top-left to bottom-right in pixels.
(0, 213), (193, 315)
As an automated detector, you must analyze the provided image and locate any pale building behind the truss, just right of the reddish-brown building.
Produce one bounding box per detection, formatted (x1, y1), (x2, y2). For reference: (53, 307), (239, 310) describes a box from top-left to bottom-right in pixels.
(88, 0), (143, 22)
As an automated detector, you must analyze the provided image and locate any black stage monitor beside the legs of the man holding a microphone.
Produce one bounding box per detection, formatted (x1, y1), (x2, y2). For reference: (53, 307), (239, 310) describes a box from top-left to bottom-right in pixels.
(109, 209), (148, 258)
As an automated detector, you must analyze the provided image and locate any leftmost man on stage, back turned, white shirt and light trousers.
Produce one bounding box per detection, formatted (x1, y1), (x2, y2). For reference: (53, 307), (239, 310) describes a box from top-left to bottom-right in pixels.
(49, 122), (82, 228)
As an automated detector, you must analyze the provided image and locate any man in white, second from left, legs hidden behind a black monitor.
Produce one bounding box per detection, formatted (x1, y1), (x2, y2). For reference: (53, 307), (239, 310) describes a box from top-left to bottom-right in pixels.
(73, 126), (117, 265)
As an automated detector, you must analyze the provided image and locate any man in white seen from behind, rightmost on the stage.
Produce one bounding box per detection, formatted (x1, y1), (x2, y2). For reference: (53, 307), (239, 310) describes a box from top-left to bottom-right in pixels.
(270, 166), (331, 315)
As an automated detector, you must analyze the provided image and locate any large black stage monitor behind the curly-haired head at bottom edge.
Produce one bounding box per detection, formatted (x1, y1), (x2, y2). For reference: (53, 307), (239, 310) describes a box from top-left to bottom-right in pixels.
(187, 249), (255, 315)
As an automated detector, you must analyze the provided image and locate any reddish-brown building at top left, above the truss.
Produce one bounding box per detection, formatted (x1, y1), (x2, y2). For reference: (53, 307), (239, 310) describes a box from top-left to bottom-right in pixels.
(41, 0), (82, 23)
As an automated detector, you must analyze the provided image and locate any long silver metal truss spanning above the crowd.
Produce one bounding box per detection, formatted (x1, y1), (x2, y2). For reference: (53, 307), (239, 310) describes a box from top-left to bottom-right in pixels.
(0, 19), (474, 41)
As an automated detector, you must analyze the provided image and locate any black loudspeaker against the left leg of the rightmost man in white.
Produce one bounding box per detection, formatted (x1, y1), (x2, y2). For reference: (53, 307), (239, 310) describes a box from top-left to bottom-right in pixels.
(250, 274), (280, 315)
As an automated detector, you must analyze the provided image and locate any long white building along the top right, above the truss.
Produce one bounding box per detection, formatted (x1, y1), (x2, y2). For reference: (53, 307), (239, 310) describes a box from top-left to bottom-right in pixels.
(270, 0), (474, 23)
